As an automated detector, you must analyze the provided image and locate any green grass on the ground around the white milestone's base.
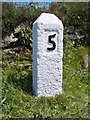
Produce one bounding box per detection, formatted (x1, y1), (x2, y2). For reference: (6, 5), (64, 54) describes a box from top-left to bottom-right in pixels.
(2, 47), (88, 119)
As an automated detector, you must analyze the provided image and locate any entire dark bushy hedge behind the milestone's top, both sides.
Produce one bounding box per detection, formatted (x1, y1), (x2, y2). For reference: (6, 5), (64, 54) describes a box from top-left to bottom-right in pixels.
(2, 2), (90, 45)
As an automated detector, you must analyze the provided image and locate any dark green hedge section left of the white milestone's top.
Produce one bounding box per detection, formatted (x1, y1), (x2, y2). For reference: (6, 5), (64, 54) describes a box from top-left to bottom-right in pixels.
(2, 2), (41, 38)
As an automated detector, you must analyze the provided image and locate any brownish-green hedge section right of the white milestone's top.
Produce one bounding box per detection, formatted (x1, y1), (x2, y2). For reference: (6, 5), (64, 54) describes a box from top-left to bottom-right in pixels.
(50, 2), (90, 45)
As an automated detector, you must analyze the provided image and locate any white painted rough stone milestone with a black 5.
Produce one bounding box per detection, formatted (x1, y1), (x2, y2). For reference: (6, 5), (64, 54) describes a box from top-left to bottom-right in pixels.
(33, 13), (63, 97)
